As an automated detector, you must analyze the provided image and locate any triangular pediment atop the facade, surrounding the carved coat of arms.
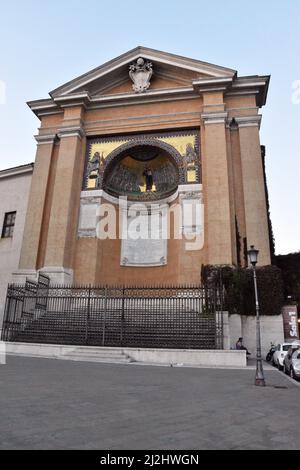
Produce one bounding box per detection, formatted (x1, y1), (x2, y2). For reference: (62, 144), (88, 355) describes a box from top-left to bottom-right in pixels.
(50, 46), (236, 98)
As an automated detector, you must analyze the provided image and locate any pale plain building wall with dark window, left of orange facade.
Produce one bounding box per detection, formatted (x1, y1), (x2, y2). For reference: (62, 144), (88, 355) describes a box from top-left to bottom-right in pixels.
(0, 171), (32, 328)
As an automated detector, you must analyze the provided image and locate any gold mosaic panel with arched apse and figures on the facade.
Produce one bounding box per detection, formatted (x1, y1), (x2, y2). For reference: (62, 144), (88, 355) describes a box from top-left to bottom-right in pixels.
(83, 130), (200, 200)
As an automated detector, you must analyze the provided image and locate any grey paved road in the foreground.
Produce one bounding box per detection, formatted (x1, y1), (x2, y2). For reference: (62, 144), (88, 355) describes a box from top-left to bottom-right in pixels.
(0, 357), (300, 450)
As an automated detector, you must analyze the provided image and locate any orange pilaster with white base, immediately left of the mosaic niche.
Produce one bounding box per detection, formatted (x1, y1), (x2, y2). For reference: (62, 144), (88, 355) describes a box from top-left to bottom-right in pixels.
(42, 108), (85, 283)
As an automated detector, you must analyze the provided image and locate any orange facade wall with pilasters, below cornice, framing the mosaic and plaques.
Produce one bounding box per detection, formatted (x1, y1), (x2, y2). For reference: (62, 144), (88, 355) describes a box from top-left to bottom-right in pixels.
(14, 78), (270, 284)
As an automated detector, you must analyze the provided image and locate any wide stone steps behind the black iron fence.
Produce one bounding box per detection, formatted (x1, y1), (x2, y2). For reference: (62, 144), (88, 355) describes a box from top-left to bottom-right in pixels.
(11, 309), (216, 349)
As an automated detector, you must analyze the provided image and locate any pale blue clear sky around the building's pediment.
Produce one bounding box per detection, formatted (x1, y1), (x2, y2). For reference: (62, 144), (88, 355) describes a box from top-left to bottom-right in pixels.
(0, 0), (300, 254)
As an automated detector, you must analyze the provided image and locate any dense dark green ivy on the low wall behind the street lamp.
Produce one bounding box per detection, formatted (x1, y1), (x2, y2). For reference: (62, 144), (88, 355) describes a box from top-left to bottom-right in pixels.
(202, 265), (284, 315)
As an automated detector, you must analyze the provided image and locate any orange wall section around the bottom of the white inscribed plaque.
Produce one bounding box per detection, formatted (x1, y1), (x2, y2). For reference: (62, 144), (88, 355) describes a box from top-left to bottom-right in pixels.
(74, 198), (205, 285)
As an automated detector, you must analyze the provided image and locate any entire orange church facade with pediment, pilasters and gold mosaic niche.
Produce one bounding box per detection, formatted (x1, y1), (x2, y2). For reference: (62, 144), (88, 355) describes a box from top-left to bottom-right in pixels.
(13, 47), (270, 285)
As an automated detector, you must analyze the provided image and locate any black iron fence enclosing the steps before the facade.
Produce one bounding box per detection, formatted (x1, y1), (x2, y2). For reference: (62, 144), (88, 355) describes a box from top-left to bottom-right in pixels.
(2, 279), (223, 349)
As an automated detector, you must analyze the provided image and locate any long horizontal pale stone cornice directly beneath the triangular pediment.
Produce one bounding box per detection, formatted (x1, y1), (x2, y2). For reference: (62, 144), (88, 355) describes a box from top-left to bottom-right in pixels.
(28, 60), (270, 117)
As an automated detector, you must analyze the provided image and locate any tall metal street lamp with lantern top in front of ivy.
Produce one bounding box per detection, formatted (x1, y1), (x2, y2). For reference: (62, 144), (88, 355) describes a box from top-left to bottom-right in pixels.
(248, 245), (266, 387)
